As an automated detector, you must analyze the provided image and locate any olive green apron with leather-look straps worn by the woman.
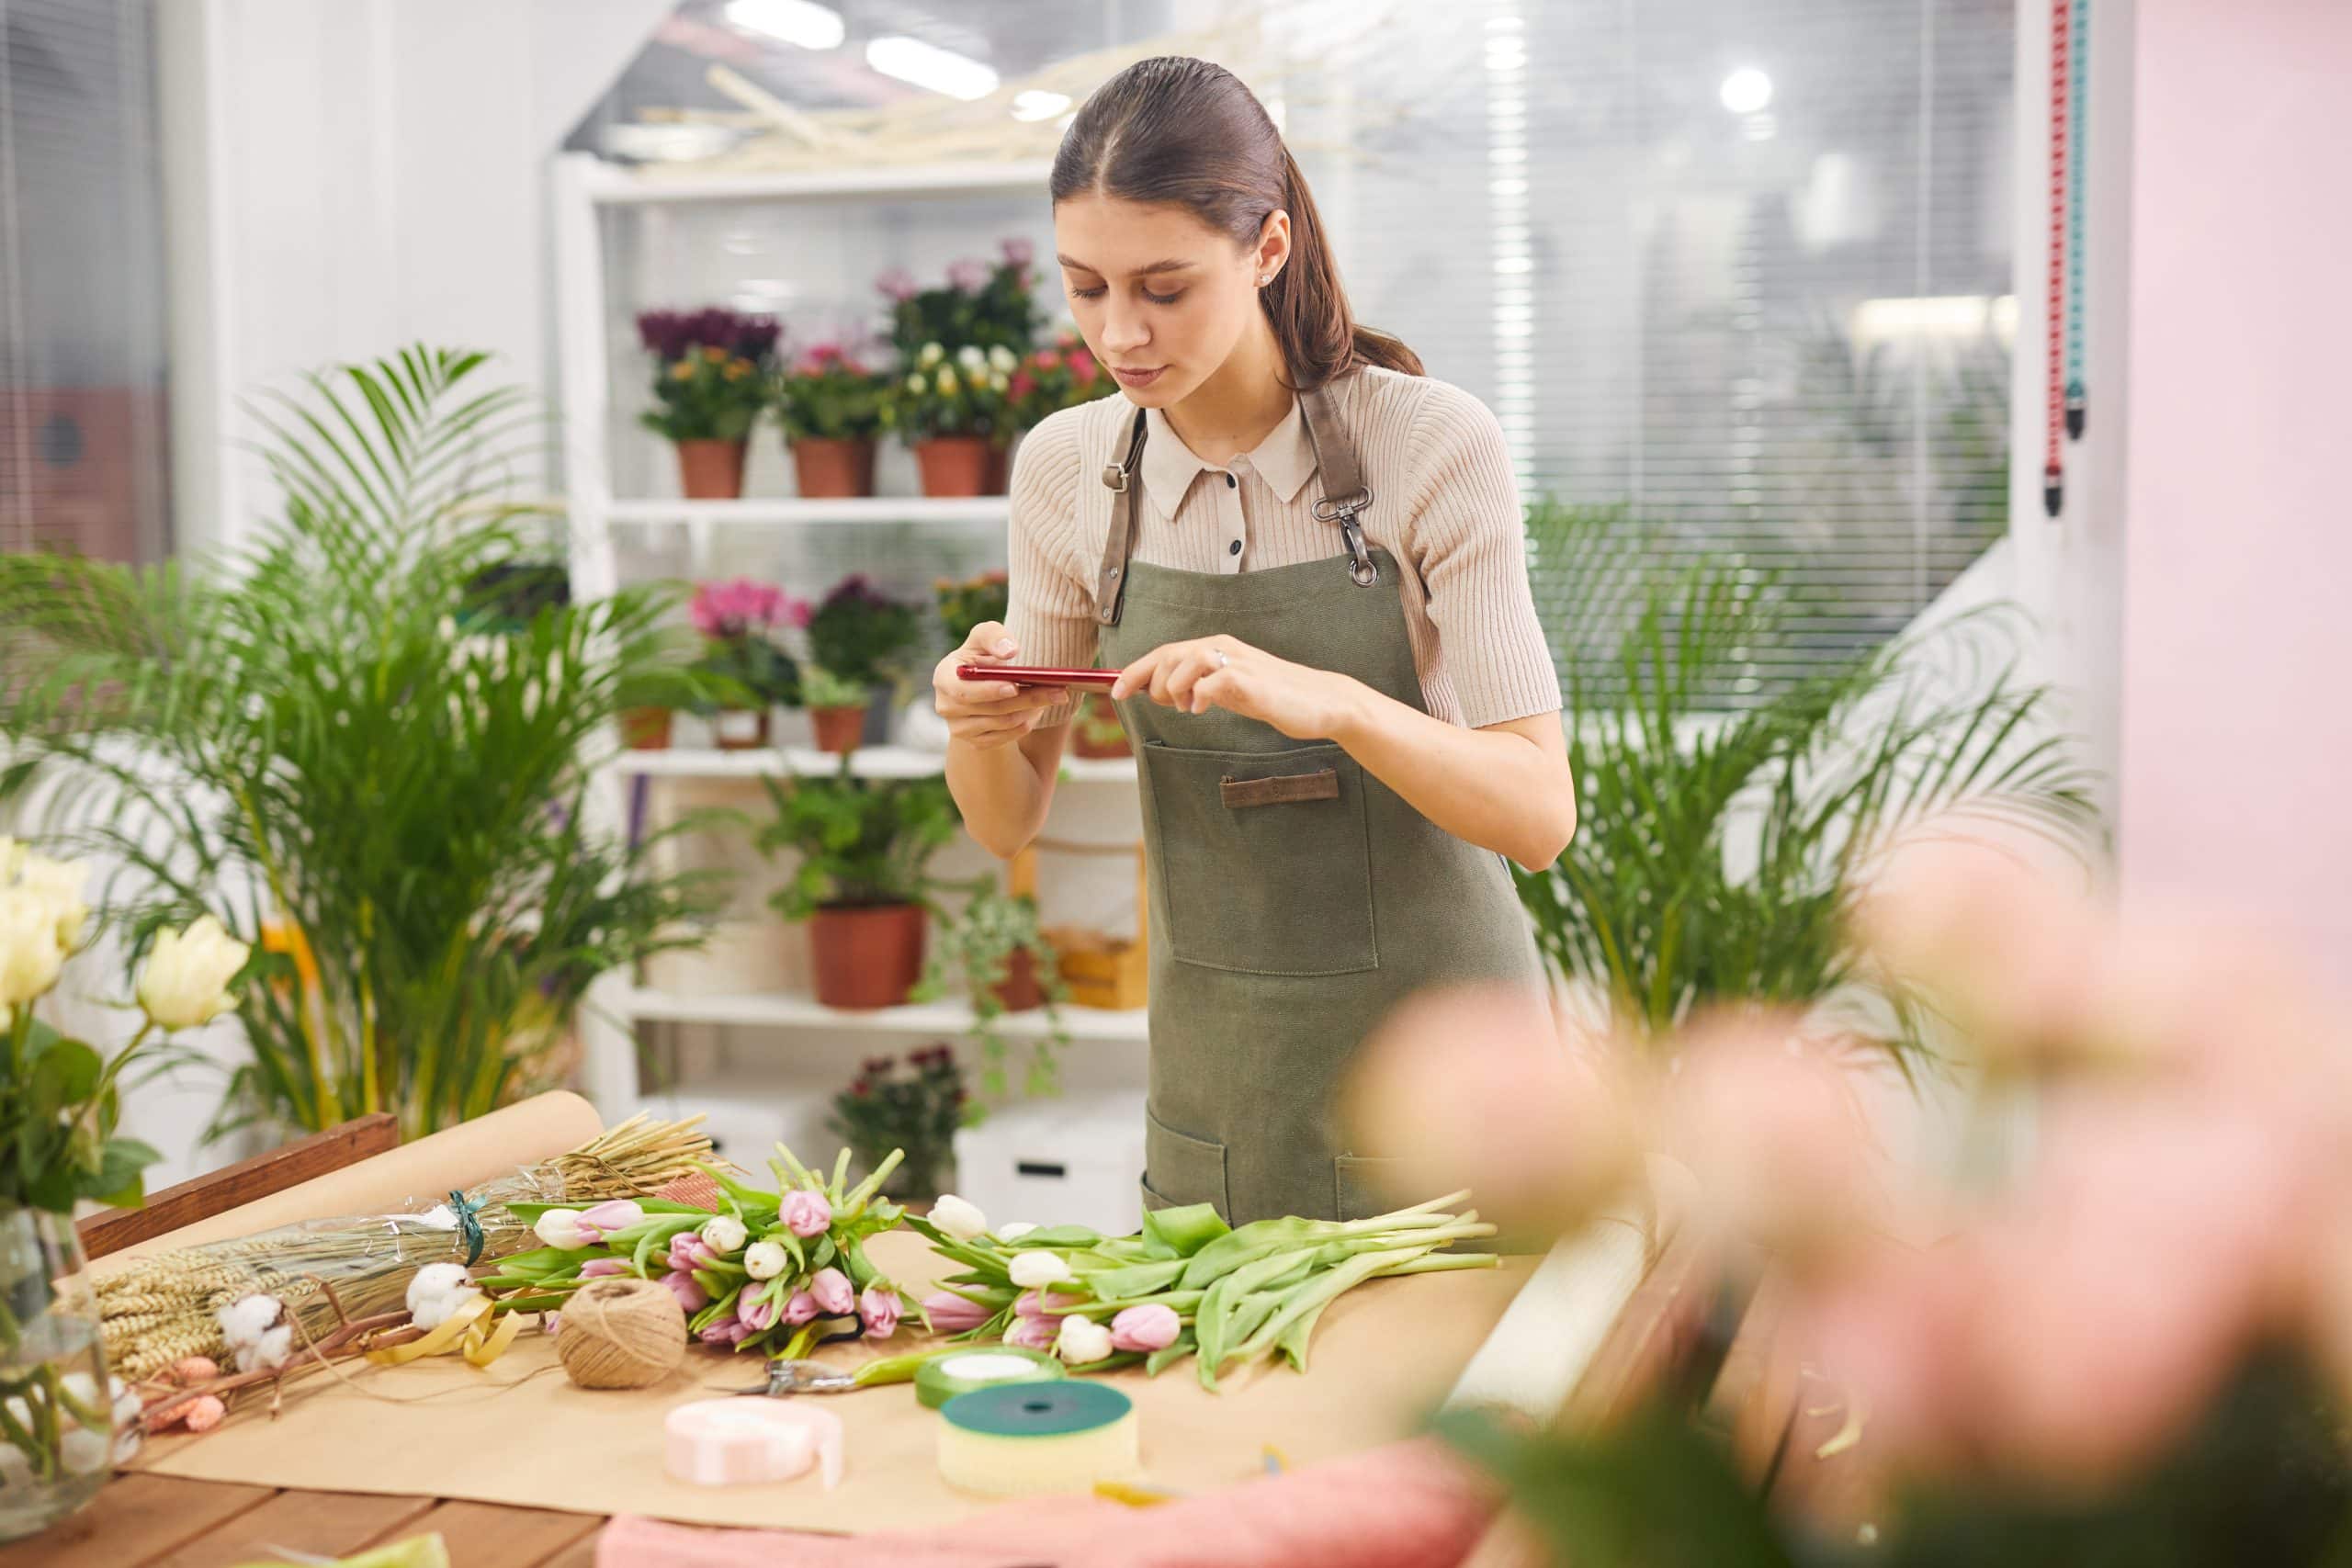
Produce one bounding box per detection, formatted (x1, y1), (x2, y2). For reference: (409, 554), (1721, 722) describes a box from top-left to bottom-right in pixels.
(1096, 376), (1541, 1224)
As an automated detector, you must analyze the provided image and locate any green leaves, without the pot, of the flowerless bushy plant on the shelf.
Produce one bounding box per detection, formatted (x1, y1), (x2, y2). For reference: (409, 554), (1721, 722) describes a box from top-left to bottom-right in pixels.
(755, 760), (962, 921)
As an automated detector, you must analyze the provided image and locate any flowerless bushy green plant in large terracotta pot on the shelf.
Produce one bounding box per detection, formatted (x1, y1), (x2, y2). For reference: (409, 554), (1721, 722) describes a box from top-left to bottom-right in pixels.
(757, 764), (959, 1009)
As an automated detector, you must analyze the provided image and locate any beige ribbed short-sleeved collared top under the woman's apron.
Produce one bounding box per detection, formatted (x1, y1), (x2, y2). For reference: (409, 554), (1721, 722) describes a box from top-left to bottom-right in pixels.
(1007, 367), (1559, 728)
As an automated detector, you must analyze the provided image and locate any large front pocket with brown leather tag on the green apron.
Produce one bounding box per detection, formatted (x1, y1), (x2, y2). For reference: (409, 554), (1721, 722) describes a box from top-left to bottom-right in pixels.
(1143, 740), (1381, 976)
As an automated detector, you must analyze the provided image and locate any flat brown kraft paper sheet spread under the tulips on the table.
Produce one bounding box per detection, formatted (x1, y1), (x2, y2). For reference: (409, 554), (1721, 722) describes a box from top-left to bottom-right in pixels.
(139, 1222), (1533, 1533)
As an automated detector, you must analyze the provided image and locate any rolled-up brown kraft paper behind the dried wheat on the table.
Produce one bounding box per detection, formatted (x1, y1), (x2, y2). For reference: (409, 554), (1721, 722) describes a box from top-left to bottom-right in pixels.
(89, 1093), (605, 1274)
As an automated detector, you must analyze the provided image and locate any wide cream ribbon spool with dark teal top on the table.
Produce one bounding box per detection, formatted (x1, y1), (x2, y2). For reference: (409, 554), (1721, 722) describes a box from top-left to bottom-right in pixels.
(938, 1382), (1143, 1497)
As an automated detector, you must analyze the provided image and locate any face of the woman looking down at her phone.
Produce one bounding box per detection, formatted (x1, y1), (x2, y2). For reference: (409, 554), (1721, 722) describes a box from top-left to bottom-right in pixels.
(1054, 195), (1289, 409)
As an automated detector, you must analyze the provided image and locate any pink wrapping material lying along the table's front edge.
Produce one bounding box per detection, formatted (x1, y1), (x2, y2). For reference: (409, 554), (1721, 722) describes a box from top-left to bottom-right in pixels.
(595, 1441), (1496, 1568)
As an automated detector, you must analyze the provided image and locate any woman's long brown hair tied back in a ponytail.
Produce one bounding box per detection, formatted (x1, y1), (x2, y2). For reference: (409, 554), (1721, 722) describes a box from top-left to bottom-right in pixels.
(1051, 54), (1423, 388)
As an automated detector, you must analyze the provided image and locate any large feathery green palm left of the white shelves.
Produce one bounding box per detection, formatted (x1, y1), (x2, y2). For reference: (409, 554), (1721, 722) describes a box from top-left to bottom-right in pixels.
(0, 348), (719, 1135)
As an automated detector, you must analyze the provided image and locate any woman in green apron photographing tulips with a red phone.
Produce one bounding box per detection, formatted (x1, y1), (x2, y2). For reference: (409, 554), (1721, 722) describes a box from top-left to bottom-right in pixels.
(933, 59), (1576, 1224)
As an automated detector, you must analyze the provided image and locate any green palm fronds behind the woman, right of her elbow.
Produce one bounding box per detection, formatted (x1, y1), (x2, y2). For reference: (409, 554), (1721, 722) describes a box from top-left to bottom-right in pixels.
(1520, 508), (2096, 1067)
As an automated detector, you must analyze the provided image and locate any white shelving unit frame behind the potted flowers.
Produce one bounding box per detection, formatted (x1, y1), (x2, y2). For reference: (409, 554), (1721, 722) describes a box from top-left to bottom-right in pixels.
(553, 152), (1146, 1117)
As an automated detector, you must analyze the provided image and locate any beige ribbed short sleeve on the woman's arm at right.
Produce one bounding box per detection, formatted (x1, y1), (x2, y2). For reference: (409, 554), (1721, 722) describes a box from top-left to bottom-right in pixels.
(1407, 381), (1559, 728)
